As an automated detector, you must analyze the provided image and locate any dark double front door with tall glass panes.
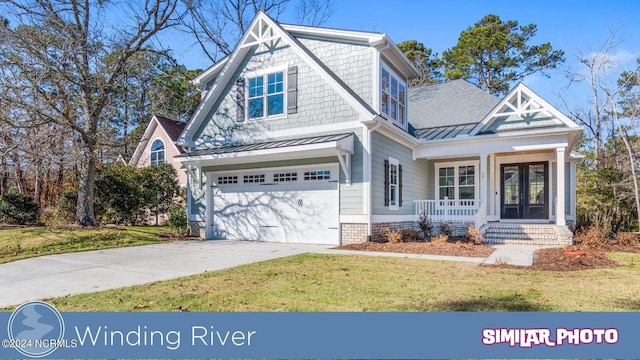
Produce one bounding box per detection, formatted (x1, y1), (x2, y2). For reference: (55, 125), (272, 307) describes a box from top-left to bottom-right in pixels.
(500, 162), (549, 219)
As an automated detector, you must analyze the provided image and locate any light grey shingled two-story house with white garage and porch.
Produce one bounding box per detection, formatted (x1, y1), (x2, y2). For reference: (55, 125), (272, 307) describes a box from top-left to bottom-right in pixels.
(176, 13), (581, 245)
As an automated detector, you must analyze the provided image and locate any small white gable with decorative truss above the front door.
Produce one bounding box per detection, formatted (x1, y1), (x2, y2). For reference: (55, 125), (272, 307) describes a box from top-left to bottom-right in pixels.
(470, 83), (579, 135)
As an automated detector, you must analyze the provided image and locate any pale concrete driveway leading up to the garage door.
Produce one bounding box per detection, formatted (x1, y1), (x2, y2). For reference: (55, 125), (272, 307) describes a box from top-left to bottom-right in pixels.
(0, 240), (330, 307)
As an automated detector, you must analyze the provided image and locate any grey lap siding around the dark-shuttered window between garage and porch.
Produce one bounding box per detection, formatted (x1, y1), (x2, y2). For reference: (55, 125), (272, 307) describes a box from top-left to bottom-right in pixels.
(371, 133), (428, 215)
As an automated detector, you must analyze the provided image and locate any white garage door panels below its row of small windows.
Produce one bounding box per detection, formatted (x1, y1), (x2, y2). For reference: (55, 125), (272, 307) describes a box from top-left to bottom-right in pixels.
(213, 169), (339, 244)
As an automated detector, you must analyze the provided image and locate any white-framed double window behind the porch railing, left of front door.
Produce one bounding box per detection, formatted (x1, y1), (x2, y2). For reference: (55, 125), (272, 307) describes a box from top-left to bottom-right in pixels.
(436, 162), (478, 205)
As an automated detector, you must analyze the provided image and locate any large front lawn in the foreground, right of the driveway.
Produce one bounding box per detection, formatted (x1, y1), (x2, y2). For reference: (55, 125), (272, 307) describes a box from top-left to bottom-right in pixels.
(49, 253), (640, 311)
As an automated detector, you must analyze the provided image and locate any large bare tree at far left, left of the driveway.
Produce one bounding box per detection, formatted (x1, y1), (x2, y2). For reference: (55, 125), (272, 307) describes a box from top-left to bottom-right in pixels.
(0, 0), (177, 225)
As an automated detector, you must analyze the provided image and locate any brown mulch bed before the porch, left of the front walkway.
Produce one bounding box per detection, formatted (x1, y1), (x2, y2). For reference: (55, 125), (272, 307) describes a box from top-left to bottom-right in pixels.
(336, 240), (495, 258)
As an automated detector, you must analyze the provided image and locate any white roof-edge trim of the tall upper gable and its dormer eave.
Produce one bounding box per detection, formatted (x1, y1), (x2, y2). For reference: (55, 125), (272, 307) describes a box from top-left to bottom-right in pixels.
(178, 12), (417, 144)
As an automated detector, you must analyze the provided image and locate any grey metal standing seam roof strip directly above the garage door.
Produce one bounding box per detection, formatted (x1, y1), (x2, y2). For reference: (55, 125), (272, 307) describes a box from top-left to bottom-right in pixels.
(179, 133), (353, 158)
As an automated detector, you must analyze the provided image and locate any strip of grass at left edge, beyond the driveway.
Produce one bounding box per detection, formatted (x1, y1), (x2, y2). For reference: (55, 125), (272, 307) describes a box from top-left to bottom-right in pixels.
(0, 226), (174, 264)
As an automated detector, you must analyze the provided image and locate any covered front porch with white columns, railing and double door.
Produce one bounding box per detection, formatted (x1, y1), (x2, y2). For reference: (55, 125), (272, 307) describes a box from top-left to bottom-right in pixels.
(414, 147), (580, 228)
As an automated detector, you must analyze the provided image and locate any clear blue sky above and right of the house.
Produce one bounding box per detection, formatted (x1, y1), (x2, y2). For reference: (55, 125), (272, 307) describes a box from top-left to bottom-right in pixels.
(159, 0), (640, 112)
